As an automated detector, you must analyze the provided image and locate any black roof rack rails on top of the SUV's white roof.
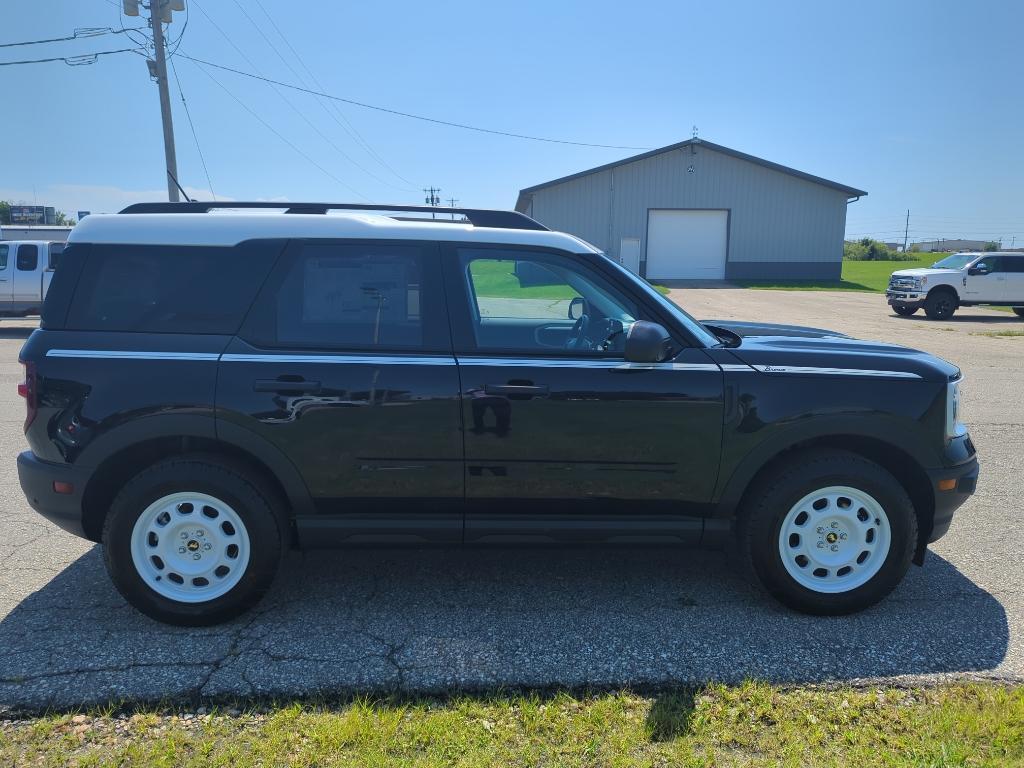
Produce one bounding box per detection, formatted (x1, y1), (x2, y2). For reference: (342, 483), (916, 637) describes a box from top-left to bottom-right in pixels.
(121, 201), (548, 231)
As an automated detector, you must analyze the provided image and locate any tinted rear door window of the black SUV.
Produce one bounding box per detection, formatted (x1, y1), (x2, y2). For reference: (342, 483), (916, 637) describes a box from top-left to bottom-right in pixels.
(243, 242), (451, 351)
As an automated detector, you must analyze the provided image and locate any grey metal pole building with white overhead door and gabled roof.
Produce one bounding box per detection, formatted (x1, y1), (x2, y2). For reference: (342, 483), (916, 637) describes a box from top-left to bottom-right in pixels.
(516, 138), (867, 281)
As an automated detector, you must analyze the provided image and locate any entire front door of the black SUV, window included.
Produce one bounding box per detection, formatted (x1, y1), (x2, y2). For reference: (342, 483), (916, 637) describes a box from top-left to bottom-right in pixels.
(444, 247), (723, 542)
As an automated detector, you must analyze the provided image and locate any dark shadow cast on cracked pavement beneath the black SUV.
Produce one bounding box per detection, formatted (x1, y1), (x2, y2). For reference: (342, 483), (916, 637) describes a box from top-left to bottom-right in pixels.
(0, 547), (1009, 709)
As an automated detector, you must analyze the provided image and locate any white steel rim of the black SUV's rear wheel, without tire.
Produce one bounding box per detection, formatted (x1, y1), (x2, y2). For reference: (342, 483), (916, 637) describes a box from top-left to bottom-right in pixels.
(131, 492), (251, 603)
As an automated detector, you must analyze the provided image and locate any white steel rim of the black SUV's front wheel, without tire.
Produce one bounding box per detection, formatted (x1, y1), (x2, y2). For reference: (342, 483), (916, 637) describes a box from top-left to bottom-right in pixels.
(778, 485), (892, 594)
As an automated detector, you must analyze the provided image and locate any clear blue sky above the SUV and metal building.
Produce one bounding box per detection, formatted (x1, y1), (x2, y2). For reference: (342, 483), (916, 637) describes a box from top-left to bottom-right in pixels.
(0, 0), (1024, 246)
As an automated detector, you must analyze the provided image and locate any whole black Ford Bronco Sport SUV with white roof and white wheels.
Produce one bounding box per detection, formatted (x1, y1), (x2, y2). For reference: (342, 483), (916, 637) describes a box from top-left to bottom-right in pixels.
(18, 203), (978, 625)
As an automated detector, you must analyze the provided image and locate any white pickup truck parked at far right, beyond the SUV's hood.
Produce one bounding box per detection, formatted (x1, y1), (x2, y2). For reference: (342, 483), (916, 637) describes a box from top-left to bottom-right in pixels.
(886, 251), (1024, 319)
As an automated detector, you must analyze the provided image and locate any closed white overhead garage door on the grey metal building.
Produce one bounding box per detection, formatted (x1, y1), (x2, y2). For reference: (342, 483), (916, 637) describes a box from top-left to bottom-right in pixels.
(647, 210), (729, 280)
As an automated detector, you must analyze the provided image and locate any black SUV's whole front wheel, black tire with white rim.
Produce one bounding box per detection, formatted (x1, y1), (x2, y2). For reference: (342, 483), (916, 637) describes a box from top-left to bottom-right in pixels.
(737, 451), (918, 615)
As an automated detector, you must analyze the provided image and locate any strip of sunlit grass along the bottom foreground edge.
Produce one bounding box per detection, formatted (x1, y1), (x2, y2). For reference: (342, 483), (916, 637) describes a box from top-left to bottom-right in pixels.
(0, 683), (1024, 767)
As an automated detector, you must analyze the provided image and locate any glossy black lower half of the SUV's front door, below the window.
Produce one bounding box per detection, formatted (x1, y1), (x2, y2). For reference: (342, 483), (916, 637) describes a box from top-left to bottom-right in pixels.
(459, 349), (722, 514)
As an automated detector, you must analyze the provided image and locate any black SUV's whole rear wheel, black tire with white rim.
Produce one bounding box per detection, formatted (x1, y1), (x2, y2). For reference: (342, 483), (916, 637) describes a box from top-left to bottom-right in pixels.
(102, 456), (285, 627)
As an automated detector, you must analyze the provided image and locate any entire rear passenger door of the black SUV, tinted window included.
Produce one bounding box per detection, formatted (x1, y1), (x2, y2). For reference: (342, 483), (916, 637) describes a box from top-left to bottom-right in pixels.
(217, 241), (464, 546)
